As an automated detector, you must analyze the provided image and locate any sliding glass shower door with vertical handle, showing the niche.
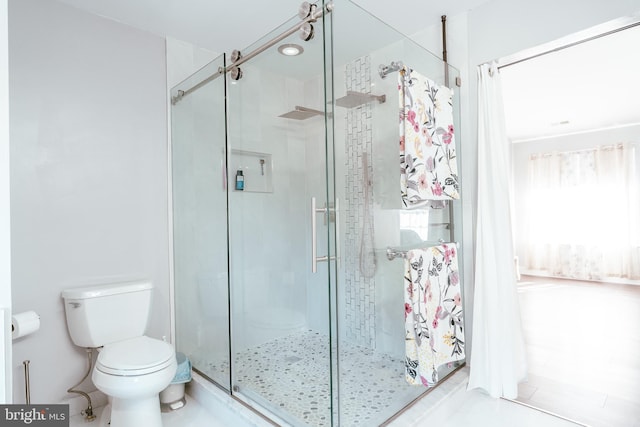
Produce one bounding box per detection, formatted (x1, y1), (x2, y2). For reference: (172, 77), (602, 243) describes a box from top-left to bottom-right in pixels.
(227, 8), (336, 426)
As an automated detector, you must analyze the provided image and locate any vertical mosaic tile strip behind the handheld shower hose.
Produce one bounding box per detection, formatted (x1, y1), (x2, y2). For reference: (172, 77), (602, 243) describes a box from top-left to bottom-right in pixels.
(343, 56), (376, 349)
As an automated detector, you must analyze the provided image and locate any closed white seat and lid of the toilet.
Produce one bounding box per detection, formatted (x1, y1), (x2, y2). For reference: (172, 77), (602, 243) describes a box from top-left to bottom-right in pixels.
(96, 336), (176, 377)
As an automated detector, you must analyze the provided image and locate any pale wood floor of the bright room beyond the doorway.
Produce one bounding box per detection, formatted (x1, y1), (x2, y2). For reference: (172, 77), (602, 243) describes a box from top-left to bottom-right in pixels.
(517, 276), (640, 427)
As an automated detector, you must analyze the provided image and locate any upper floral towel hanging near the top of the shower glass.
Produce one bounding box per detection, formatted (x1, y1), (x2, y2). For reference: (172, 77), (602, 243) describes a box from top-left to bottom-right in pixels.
(398, 67), (460, 207)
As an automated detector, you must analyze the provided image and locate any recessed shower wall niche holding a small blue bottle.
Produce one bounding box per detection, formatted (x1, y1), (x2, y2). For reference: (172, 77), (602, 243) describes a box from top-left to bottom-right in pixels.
(229, 149), (273, 193)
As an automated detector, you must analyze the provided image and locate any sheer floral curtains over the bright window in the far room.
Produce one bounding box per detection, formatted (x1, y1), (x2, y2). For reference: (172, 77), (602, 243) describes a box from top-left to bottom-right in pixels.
(525, 144), (640, 280)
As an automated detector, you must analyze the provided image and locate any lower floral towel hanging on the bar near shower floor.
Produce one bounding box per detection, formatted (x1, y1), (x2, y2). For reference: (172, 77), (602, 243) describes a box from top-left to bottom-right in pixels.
(404, 243), (465, 387)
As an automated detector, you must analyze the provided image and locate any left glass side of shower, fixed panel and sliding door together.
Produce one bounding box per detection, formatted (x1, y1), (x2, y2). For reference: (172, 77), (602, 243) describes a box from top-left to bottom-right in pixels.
(172, 6), (339, 426)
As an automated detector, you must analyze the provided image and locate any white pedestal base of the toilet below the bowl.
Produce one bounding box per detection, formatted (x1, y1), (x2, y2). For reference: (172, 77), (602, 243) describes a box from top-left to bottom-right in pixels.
(100, 395), (162, 427)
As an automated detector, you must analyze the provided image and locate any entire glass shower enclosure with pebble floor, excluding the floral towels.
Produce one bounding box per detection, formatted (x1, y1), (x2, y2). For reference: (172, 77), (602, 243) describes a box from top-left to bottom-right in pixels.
(171, 1), (462, 426)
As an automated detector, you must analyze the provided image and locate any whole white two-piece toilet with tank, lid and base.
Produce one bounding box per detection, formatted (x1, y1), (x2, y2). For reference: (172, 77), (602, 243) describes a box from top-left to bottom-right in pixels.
(62, 282), (177, 427)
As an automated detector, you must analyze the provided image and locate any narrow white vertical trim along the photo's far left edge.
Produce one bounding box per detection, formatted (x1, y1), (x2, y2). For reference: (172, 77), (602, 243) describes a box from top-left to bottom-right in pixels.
(0, 0), (11, 403)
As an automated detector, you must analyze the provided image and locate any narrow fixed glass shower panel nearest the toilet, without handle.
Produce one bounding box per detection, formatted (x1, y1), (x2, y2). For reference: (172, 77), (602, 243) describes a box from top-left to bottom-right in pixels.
(171, 56), (230, 390)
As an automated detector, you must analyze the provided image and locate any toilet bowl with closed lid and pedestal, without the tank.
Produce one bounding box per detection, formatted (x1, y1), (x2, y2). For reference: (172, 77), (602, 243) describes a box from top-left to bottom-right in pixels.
(91, 336), (177, 427)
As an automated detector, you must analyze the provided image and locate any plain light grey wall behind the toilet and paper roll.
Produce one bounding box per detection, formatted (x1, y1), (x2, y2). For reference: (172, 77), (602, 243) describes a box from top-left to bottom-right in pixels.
(9, 0), (170, 403)
